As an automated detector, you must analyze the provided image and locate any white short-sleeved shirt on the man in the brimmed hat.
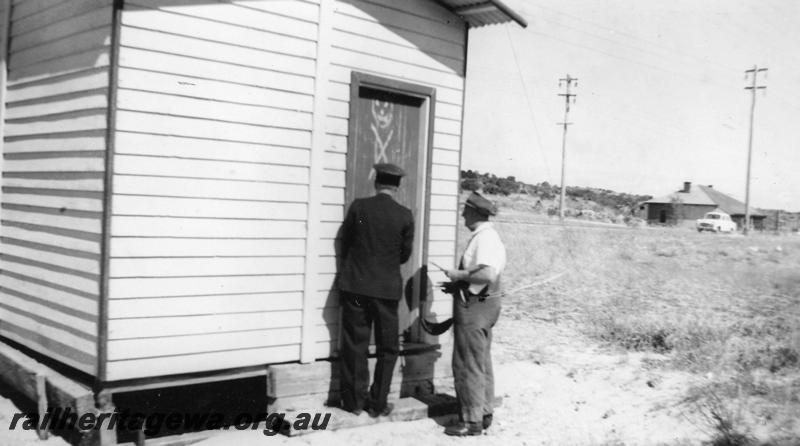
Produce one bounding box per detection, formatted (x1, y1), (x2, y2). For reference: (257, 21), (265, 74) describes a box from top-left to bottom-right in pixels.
(461, 221), (506, 294)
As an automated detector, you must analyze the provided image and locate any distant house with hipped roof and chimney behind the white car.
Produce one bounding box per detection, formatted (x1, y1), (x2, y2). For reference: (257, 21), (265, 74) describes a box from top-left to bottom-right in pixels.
(640, 181), (766, 229)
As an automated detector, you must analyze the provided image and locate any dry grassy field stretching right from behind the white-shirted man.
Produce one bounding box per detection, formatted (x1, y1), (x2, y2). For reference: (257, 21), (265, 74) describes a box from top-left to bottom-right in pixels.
(460, 198), (800, 444)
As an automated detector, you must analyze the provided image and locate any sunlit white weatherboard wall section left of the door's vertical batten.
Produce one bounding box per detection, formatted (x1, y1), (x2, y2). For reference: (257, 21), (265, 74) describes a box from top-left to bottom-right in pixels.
(108, 0), (322, 380)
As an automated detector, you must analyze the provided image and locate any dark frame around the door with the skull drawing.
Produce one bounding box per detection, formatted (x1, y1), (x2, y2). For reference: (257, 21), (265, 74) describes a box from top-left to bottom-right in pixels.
(345, 71), (436, 339)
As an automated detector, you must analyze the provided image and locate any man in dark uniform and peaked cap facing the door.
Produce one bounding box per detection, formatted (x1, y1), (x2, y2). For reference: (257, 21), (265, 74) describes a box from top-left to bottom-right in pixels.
(339, 164), (414, 417)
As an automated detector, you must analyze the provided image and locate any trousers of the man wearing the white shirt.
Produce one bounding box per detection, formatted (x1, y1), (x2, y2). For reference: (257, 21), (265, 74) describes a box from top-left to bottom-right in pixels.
(453, 296), (500, 423)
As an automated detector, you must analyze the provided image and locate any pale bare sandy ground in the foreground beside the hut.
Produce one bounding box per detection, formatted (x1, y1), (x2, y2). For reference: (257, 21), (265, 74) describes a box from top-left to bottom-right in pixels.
(0, 314), (710, 446)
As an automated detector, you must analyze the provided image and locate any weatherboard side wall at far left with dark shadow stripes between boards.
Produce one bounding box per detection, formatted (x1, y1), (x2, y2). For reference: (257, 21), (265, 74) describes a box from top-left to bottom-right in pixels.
(0, 0), (113, 374)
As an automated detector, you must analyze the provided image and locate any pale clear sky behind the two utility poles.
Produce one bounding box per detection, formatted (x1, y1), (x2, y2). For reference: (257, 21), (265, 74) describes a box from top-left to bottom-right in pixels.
(462, 0), (800, 212)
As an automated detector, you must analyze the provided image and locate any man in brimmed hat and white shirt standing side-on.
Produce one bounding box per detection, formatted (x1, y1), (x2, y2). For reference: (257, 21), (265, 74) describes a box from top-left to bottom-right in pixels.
(445, 192), (506, 436)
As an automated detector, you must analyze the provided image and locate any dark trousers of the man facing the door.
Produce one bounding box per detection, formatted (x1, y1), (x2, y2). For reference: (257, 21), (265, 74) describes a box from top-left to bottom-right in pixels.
(339, 291), (400, 411)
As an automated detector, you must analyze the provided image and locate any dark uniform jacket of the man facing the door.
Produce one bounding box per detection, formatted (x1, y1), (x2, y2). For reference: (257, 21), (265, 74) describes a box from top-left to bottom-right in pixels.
(339, 193), (414, 300)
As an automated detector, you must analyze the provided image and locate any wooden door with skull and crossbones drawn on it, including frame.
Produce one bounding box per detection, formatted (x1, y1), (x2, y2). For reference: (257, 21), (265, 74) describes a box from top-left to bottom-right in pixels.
(345, 73), (434, 340)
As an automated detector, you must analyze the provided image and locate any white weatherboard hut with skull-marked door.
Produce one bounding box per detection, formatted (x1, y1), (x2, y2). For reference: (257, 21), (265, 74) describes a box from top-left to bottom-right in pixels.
(0, 0), (525, 436)
